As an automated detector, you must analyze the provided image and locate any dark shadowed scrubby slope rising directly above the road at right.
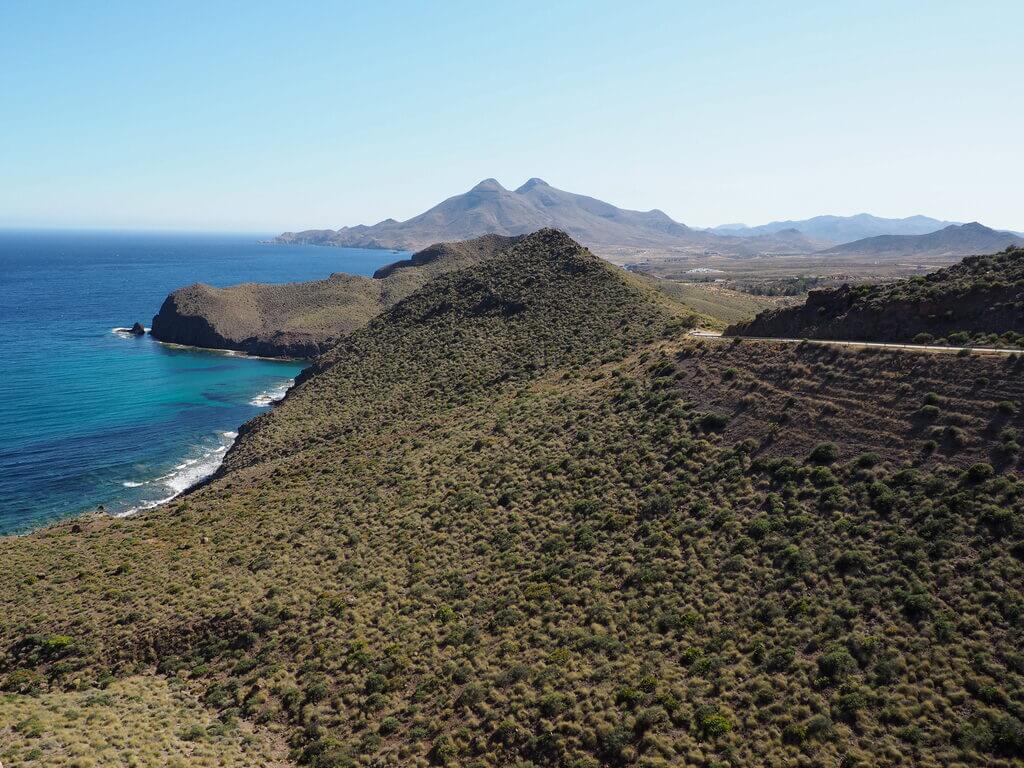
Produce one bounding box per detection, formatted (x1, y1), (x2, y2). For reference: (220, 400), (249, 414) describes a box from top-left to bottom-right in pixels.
(726, 248), (1024, 345)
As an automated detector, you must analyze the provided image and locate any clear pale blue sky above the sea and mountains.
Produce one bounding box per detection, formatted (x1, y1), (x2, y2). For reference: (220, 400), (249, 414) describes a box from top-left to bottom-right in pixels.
(0, 0), (1024, 231)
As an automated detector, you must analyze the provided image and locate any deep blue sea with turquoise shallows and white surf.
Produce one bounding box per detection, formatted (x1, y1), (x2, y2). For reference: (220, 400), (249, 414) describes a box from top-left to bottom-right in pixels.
(0, 230), (407, 535)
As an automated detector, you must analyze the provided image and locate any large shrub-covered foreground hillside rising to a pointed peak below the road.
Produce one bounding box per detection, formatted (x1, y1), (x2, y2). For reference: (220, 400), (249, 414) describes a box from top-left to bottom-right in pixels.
(0, 231), (1024, 768)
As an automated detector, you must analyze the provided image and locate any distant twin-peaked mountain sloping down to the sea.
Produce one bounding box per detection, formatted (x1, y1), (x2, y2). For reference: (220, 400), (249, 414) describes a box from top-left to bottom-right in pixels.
(278, 178), (701, 250)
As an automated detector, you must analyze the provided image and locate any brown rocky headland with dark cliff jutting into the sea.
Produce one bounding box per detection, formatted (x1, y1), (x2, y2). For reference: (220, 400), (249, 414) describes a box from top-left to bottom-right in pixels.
(152, 236), (514, 357)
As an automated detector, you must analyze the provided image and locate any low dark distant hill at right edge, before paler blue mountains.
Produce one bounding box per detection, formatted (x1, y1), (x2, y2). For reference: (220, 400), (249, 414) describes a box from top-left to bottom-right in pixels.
(820, 221), (1024, 259)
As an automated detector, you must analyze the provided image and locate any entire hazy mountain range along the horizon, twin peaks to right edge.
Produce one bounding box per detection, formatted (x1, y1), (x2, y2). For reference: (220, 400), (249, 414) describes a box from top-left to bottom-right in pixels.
(275, 178), (1017, 258)
